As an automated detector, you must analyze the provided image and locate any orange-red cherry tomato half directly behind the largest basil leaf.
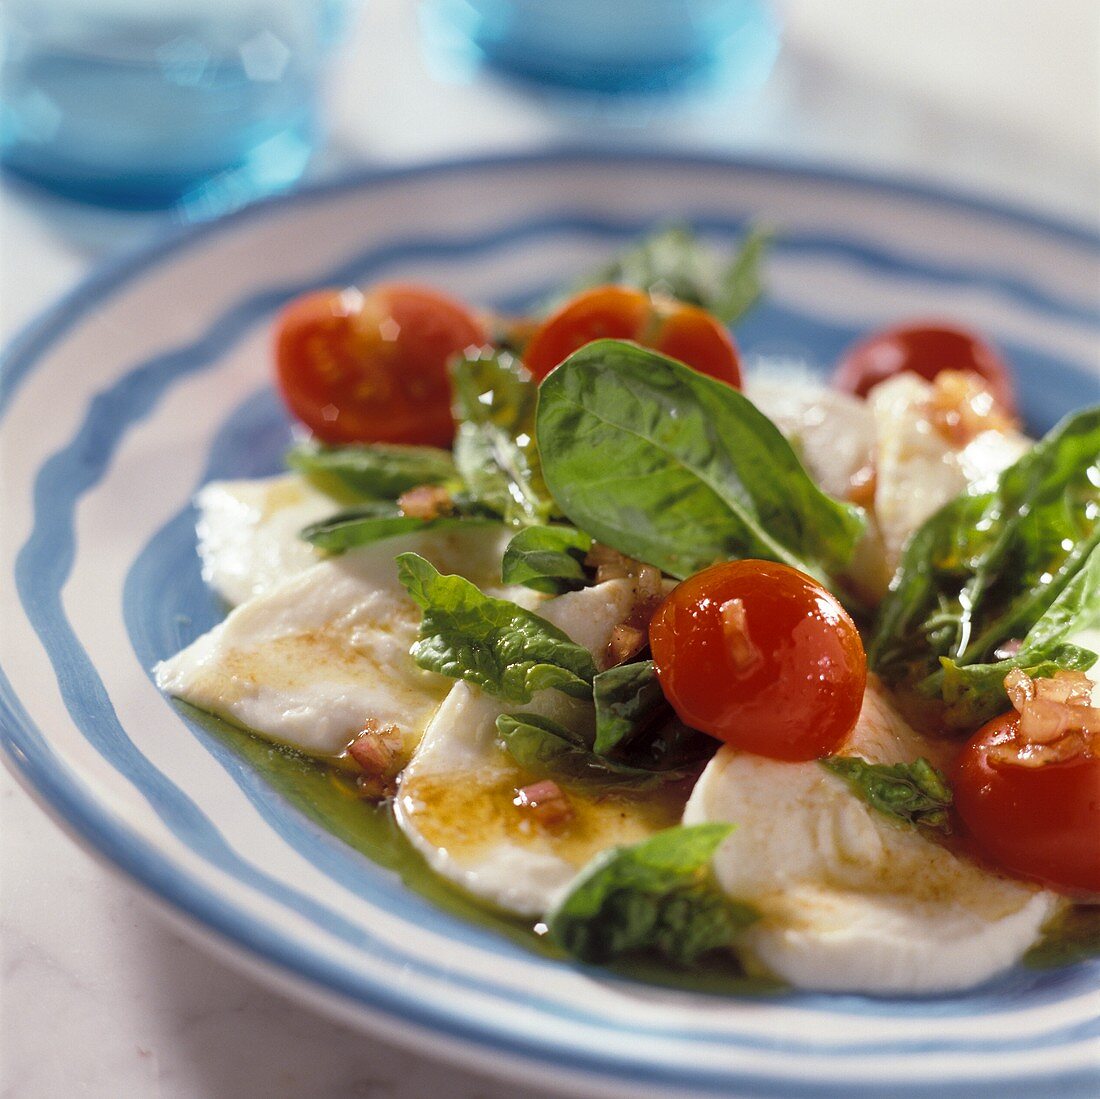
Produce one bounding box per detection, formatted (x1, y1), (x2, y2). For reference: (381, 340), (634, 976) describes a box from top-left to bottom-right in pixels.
(524, 286), (741, 388)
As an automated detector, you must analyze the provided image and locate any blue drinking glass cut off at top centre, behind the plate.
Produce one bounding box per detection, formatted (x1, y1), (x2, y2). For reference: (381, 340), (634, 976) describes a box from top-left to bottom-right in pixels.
(422, 0), (780, 96)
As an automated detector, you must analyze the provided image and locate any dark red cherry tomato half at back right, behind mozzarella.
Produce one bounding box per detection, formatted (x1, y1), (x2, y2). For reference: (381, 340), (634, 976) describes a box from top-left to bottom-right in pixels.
(833, 322), (1016, 416)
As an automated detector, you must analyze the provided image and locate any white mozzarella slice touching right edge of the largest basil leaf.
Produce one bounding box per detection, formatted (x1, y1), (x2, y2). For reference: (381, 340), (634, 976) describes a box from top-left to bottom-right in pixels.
(745, 373), (875, 499)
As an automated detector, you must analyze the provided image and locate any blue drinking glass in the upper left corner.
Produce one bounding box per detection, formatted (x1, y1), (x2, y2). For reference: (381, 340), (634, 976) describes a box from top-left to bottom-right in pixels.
(0, 0), (348, 212)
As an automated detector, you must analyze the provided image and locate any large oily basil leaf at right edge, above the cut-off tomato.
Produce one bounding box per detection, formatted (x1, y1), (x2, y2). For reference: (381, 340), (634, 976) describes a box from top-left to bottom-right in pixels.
(868, 407), (1100, 727)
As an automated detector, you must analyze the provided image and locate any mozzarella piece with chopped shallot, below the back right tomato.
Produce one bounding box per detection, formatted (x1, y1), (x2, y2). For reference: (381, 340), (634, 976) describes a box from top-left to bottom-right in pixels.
(868, 374), (1031, 571)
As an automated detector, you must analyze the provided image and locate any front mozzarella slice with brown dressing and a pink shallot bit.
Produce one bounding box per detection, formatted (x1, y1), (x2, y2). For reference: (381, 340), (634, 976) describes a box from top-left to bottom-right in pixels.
(395, 580), (683, 915)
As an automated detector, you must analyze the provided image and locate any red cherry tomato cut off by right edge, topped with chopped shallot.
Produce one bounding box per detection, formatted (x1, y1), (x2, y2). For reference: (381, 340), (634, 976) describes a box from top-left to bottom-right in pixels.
(954, 710), (1100, 894)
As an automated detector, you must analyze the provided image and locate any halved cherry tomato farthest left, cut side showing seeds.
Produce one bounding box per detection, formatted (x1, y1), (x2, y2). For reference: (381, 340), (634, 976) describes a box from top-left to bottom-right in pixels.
(275, 284), (487, 447)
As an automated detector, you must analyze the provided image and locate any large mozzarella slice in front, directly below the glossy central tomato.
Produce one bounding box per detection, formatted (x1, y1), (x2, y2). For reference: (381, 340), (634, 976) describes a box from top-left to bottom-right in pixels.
(684, 681), (1062, 994)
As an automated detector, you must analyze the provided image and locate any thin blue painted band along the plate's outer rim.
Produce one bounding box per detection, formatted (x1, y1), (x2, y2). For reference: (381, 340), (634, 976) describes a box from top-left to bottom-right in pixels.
(0, 146), (1100, 1088)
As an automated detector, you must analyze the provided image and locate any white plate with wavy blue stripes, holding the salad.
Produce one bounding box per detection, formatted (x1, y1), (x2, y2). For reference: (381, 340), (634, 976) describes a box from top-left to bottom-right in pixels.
(0, 153), (1100, 1099)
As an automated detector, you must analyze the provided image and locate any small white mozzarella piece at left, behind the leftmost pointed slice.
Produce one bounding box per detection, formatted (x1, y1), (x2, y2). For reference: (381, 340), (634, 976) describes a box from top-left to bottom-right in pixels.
(195, 473), (340, 606)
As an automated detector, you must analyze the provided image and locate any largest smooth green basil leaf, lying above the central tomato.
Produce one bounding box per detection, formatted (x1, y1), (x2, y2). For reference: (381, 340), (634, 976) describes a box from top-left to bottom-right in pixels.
(537, 340), (865, 579)
